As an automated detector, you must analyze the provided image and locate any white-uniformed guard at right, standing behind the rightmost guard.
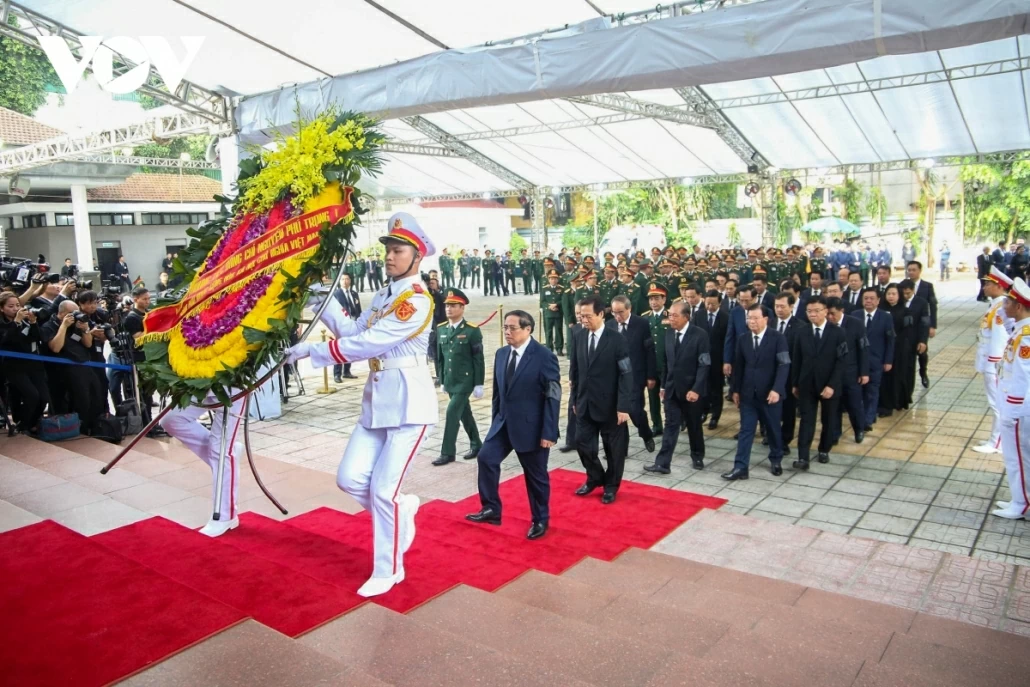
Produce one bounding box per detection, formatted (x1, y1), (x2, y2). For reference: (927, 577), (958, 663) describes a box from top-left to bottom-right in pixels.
(972, 266), (1012, 453)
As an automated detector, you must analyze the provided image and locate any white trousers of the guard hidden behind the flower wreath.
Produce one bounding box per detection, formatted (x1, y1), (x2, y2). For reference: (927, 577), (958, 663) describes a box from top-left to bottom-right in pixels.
(161, 396), (243, 520)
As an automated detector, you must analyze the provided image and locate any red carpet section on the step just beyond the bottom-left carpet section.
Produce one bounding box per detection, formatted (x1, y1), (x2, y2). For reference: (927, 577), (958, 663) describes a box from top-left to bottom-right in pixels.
(93, 518), (365, 637)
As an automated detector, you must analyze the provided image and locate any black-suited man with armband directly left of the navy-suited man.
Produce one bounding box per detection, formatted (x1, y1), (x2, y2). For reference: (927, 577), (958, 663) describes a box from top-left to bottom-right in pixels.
(644, 301), (712, 475)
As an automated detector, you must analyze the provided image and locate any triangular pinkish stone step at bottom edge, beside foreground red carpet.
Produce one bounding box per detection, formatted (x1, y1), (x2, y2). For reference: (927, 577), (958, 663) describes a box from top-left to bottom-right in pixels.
(117, 620), (388, 687)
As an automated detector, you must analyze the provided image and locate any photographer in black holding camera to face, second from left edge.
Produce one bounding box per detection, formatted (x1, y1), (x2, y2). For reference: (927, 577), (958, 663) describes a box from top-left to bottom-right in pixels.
(42, 301), (100, 434)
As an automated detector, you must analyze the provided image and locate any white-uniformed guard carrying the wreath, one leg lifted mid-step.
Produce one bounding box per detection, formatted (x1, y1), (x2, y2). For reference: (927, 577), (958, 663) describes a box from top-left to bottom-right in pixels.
(286, 212), (440, 596)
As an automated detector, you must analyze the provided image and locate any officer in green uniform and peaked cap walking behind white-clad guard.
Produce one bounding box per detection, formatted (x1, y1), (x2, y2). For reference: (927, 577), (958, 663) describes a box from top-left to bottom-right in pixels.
(433, 287), (486, 466)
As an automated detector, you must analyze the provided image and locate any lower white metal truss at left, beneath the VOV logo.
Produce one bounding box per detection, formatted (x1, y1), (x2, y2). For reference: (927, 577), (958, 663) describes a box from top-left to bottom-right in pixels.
(0, 112), (229, 175)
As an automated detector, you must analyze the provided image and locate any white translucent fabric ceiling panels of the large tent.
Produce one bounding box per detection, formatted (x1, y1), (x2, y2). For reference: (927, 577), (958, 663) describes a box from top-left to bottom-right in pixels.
(22, 0), (1030, 197)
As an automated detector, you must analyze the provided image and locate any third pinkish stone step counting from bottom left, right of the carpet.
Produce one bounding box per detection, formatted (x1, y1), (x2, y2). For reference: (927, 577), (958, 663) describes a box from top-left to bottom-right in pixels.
(411, 585), (671, 687)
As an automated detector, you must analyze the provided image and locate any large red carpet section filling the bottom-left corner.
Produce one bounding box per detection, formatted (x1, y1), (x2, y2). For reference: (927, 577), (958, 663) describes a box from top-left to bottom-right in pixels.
(0, 521), (244, 687)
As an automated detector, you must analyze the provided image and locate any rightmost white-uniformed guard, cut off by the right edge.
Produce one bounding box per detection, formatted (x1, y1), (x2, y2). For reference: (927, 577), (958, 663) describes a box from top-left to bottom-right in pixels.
(991, 277), (1030, 520)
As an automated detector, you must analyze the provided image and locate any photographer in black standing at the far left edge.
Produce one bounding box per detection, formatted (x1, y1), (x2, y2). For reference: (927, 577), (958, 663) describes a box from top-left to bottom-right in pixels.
(0, 291), (50, 433)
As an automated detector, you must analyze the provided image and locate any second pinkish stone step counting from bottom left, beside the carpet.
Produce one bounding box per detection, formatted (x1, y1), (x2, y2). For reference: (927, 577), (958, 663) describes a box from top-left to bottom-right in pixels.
(298, 604), (588, 687)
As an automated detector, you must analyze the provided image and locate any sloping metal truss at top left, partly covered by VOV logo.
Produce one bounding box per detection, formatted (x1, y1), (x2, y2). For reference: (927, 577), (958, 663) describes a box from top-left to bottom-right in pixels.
(0, 2), (232, 126)
